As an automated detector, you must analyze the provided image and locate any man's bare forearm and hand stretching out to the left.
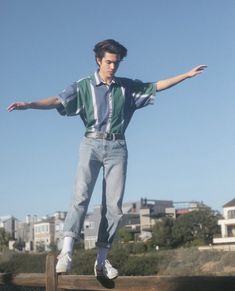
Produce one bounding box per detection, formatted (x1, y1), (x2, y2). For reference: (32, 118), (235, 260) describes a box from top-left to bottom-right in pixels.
(7, 96), (61, 112)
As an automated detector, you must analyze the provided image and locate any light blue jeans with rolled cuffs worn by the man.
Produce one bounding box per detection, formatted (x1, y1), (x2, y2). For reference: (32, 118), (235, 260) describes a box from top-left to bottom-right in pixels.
(64, 137), (128, 248)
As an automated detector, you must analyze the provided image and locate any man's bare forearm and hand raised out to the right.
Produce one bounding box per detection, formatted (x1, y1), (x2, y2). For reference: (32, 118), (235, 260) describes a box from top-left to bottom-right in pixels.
(156, 65), (207, 91)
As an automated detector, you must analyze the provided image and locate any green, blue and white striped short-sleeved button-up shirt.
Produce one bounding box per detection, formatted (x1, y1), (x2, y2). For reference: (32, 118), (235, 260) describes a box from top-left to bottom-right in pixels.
(58, 72), (156, 134)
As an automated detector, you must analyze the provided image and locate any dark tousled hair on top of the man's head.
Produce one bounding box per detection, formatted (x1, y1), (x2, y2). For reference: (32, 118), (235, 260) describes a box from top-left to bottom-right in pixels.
(93, 39), (127, 60)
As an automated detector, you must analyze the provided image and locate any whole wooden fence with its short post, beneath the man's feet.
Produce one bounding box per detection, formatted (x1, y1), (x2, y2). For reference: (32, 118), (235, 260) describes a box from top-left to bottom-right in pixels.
(0, 254), (235, 291)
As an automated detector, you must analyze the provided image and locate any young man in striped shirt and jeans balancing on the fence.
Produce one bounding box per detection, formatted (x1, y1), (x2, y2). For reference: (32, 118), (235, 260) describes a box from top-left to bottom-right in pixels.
(8, 39), (206, 279)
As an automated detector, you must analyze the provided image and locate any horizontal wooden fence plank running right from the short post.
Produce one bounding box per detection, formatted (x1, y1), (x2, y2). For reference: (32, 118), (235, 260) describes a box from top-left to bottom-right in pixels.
(58, 275), (235, 291)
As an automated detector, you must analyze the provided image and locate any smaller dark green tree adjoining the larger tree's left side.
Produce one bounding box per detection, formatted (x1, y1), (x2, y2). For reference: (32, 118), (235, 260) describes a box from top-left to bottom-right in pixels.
(152, 217), (174, 247)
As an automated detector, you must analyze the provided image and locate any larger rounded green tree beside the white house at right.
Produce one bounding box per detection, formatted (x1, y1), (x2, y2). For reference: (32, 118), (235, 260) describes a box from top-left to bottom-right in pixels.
(172, 208), (221, 246)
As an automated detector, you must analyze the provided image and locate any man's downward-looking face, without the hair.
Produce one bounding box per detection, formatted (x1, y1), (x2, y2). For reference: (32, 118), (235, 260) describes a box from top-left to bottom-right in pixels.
(97, 52), (120, 79)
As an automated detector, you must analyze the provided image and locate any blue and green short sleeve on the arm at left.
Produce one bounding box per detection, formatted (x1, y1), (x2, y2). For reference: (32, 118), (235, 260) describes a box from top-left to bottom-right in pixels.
(57, 82), (82, 116)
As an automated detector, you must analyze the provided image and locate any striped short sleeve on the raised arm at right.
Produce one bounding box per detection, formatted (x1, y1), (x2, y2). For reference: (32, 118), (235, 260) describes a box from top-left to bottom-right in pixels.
(132, 80), (156, 109)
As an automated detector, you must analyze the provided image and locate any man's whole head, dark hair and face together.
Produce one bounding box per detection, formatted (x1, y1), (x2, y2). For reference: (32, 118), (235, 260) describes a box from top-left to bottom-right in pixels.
(94, 39), (127, 81)
